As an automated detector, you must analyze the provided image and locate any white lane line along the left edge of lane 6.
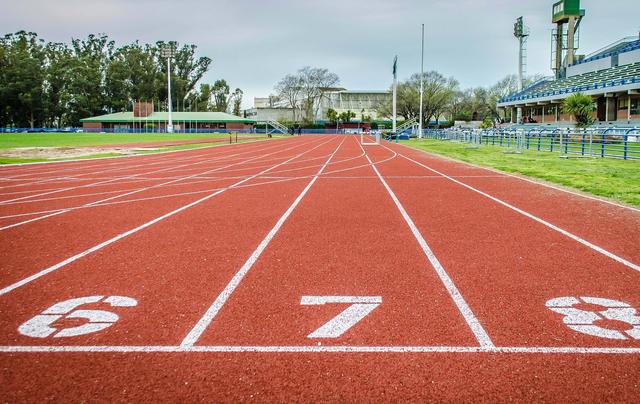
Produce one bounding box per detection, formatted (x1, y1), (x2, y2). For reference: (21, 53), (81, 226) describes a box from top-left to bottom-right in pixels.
(0, 140), (330, 296)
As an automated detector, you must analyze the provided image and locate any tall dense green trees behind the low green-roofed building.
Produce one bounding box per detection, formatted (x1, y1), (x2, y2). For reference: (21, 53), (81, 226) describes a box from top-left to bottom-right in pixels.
(0, 31), (242, 128)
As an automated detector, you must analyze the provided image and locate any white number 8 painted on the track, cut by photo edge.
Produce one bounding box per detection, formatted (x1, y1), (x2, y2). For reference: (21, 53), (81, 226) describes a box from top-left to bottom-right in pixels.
(547, 297), (640, 339)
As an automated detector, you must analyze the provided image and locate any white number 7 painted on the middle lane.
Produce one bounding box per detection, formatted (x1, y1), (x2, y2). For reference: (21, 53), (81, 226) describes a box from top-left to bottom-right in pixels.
(300, 296), (382, 338)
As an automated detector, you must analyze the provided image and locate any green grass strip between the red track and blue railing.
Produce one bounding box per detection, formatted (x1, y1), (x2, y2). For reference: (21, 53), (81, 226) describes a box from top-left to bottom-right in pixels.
(403, 139), (640, 206)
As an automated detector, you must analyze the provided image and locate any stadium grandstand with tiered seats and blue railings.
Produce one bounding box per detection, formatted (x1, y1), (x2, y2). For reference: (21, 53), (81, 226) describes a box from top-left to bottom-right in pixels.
(498, 0), (640, 125)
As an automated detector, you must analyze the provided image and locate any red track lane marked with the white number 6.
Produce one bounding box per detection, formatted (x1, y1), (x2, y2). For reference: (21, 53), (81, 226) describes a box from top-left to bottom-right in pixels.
(0, 139), (337, 345)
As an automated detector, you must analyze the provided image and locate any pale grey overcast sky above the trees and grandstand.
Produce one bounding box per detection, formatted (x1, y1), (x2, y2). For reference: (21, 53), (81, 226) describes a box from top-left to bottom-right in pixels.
(0, 0), (640, 108)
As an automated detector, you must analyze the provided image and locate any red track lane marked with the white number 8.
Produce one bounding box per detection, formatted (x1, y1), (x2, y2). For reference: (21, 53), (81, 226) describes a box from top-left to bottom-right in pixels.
(368, 142), (640, 347)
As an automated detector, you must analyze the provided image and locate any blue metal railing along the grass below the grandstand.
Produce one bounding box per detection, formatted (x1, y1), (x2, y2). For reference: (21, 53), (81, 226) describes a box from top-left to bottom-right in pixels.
(424, 127), (640, 160)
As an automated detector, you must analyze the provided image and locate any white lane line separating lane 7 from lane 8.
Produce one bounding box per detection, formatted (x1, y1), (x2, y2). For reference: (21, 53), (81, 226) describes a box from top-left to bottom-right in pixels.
(366, 142), (494, 347)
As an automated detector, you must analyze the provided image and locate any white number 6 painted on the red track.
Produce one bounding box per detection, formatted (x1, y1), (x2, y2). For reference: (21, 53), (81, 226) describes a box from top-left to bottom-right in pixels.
(18, 296), (138, 338)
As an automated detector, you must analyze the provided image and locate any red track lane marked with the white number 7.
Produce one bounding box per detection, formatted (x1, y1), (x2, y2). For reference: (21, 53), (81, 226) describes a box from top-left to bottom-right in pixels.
(191, 138), (478, 346)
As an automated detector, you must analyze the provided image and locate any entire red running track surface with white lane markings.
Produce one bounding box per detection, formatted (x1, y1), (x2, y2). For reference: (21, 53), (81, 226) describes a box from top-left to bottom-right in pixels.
(0, 136), (640, 402)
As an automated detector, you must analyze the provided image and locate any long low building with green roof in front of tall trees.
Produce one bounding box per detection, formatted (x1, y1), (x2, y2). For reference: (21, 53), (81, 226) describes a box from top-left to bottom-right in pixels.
(80, 102), (255, 132)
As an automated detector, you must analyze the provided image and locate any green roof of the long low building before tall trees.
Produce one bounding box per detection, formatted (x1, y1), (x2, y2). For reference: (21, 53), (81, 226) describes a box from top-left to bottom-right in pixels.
(80, 112), (255, 123)
